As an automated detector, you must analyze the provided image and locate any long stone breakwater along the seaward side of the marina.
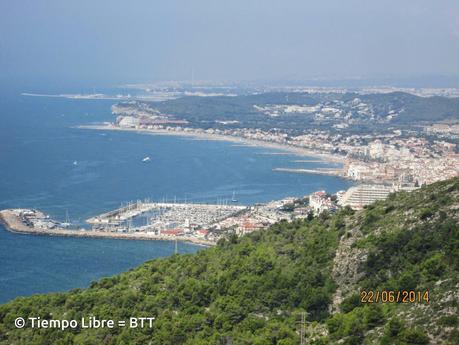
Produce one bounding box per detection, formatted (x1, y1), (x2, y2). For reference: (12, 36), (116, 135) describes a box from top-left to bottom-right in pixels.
(0, 209), (216, 247)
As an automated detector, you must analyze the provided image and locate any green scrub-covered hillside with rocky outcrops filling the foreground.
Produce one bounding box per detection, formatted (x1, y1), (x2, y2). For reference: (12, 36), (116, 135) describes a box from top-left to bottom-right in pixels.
(0, 178), (459, 345)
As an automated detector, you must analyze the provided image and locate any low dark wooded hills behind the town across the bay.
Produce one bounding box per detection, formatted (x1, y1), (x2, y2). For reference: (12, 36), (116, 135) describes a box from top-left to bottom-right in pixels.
(150, 92), (459, 135)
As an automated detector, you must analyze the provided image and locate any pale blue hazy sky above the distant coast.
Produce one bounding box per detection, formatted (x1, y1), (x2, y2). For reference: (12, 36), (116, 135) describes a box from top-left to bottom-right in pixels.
(0, 0), (459, 82)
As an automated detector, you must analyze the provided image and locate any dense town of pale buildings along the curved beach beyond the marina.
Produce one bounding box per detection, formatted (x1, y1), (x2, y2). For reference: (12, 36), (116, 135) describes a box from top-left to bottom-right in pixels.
(111, 99), (459, 186)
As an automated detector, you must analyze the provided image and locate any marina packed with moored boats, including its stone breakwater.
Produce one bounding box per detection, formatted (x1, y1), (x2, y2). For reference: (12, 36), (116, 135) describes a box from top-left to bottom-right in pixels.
(0, 200), (247, 245)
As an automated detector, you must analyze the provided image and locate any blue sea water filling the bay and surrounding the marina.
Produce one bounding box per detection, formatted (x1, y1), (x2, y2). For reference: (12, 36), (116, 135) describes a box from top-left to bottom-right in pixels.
(0, 90), (349, 303)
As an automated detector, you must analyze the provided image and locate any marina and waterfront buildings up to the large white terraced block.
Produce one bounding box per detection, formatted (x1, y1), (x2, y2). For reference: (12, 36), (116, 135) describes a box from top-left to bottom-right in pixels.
(0, 180), (408, 245)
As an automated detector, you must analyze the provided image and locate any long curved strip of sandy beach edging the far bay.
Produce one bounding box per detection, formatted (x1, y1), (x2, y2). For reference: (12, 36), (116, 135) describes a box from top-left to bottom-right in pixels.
(74, 124), (345, 164)
